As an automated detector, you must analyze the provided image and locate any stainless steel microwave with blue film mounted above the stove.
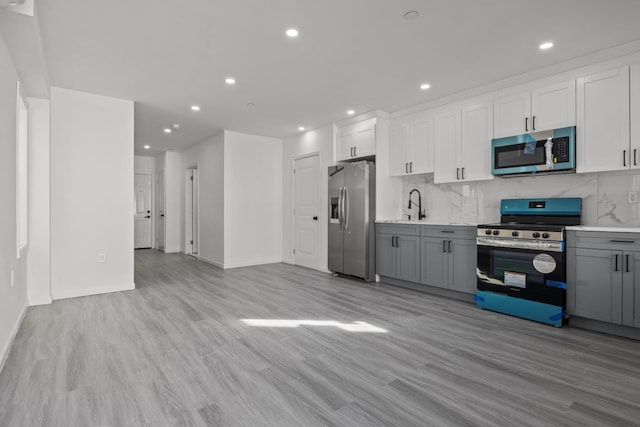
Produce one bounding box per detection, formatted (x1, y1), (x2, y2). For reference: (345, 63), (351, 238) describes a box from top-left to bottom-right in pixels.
(491, 126), (576, 175)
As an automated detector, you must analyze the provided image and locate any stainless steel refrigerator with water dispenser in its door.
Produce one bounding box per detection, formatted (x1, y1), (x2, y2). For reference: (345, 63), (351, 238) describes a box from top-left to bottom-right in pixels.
(329, 161), (376, 281)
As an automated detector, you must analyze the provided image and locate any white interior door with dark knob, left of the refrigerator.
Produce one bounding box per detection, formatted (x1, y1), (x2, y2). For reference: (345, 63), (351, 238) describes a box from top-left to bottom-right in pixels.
(293, 154), (320, 268)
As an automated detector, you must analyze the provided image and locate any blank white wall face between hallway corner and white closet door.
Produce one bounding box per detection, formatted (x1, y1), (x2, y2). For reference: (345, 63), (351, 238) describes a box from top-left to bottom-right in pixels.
(224, 131), (282, 268)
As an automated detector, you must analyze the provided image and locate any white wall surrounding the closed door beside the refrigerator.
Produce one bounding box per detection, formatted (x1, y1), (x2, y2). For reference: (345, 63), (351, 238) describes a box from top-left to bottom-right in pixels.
(282, 124), (333, 271)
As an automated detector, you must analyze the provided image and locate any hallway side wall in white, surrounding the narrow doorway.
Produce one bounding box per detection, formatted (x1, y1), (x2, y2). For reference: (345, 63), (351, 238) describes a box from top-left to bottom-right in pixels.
(180, 132), (225, 267)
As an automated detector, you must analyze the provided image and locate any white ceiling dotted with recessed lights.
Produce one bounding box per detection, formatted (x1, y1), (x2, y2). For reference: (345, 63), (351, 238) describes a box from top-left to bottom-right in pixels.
(6, 0), (640, 154)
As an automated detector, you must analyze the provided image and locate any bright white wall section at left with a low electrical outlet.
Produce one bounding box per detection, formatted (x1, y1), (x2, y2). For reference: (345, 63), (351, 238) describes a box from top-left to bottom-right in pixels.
(51, 87), (134, 299)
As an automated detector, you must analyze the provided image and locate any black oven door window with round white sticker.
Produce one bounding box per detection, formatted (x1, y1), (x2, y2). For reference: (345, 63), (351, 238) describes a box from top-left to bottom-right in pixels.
(478, 246), (566, 305)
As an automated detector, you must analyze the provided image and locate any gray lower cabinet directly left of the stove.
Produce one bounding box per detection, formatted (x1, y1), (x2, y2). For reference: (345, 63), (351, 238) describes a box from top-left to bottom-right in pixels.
(420, 226), (478, 294)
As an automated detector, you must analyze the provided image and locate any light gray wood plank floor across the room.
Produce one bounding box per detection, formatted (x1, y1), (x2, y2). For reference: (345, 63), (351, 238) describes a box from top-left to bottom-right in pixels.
(0, 250), (640, 427)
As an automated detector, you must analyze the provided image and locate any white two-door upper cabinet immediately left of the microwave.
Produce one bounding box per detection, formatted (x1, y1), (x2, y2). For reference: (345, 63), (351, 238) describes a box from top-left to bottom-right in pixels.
(434, 100), (493, 183)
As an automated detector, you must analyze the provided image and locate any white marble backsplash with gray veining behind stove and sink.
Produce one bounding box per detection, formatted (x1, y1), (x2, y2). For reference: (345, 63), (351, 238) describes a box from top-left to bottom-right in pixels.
(402, 171), (640, 226)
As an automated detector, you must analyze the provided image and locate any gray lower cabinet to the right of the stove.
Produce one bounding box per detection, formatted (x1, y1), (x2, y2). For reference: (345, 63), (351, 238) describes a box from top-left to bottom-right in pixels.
(567, 231), (640, 327)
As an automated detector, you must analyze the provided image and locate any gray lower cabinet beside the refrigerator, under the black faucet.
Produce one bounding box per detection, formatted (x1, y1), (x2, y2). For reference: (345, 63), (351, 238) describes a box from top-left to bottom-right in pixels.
(376, 224), (420, 283)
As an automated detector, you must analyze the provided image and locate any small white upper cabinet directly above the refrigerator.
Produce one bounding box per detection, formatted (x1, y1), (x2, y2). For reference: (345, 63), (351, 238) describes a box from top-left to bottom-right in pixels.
(336, 119), (376, 161)
